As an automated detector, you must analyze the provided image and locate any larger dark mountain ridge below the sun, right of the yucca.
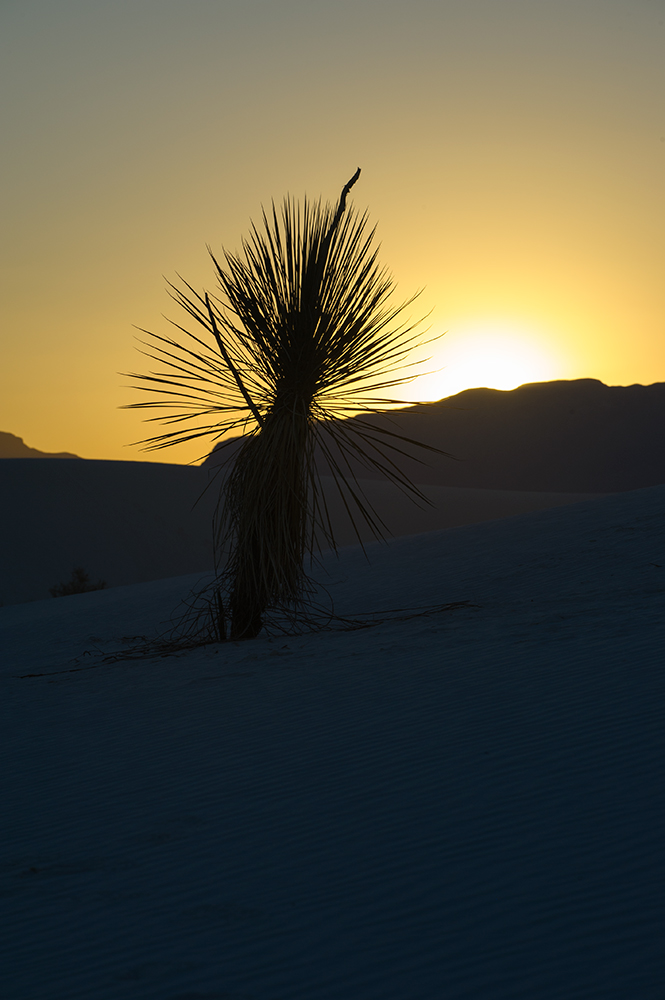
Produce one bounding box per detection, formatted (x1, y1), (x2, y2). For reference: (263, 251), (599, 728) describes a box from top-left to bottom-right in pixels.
(204, 379), (665, 493)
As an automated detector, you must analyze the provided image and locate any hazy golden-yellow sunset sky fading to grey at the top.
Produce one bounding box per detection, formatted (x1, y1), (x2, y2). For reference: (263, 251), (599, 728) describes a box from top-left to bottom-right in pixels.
(0, 0), (665, 462)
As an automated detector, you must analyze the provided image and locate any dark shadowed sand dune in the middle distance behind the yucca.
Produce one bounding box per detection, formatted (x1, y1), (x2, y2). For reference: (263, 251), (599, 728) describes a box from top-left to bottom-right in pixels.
(0, 459), (600, 604)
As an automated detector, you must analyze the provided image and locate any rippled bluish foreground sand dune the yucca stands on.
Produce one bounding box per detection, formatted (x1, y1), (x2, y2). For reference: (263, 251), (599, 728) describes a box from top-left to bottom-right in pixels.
(0, 487), (665, 1000)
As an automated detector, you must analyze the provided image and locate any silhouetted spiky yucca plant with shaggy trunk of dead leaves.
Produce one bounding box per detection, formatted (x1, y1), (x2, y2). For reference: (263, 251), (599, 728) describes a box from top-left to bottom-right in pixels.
(125, 169), (446, 639)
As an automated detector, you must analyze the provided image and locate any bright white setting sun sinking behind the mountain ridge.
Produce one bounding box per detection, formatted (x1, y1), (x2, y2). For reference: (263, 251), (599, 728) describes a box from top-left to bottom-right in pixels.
(402, 321), (565, 402)
